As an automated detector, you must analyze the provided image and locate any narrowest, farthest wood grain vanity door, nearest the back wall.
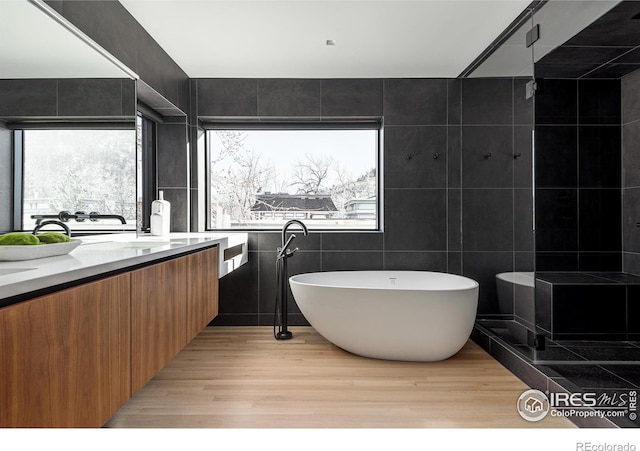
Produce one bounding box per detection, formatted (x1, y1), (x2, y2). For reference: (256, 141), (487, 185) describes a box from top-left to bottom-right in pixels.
(187, 246), (219, 341)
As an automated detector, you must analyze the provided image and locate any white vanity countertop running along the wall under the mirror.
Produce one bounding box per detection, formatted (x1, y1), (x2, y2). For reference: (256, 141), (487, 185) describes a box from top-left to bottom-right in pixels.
(0, 233), (248, 307)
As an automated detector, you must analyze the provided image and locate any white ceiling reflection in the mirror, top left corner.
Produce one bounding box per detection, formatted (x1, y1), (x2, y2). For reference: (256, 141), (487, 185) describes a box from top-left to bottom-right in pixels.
(0, 0), (129, 78)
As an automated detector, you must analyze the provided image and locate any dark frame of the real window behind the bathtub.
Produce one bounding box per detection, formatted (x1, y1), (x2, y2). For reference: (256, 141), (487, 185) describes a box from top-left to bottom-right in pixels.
(200, 117), (384, 233)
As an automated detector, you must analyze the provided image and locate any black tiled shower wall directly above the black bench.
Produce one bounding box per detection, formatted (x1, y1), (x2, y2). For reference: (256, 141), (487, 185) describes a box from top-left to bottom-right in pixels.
(535, 79), (622, 271)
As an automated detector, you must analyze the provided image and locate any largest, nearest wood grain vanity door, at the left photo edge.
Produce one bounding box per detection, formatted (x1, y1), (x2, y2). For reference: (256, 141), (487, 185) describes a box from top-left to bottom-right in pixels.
(0, 274), (131, 427)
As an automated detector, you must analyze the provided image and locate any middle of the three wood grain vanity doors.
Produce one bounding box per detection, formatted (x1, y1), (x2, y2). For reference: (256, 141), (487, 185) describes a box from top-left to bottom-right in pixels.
(131, 257), (188, 395)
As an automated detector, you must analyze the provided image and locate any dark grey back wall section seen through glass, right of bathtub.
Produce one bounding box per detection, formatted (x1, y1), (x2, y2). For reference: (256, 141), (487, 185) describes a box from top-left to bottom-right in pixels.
(460, 78), (533, 319)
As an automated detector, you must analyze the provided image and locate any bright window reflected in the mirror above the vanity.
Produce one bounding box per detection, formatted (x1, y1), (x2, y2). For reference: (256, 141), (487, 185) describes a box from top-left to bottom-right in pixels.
(16, 129), (136, 231)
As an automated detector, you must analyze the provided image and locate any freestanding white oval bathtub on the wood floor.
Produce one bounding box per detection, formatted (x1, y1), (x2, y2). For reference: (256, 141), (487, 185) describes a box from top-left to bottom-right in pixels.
(289, 271), (478, 361)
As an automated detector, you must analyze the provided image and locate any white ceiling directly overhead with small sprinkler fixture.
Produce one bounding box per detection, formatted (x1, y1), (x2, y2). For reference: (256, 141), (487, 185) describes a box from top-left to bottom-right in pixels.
(120, 0), (530, 78)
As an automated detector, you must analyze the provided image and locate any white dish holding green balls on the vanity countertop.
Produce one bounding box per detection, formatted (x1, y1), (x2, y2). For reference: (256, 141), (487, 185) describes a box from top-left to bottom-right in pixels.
(0, 232), (82, 261)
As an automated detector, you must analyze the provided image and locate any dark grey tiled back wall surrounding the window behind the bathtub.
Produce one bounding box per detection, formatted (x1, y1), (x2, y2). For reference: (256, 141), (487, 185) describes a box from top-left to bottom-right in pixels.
(196, 79), (533, 325)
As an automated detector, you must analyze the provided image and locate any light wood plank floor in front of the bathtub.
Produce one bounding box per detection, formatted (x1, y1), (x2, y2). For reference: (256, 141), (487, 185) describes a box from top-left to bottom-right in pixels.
(106, 327), (573, 428)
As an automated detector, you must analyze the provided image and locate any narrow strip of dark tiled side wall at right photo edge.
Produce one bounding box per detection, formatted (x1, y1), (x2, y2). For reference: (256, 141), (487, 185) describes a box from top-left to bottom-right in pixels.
(622, 70), (640, 275)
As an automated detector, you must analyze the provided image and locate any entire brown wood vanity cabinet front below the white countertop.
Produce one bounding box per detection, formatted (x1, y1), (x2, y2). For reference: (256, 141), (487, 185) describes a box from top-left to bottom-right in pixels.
(0, 246), (219, 427)
